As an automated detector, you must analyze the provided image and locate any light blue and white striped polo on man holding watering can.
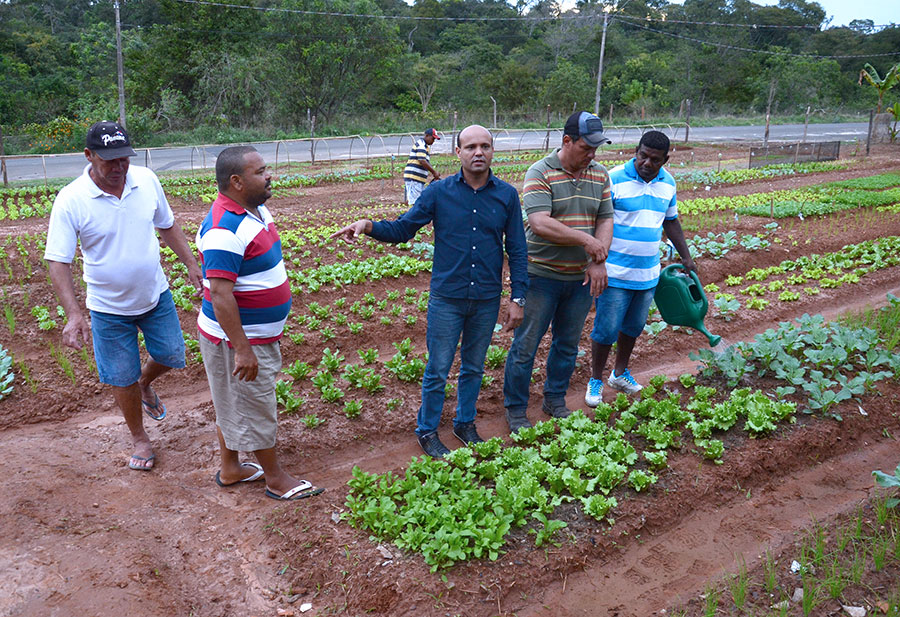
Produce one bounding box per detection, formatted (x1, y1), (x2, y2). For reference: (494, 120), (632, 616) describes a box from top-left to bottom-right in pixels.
(606, 159), (678, 289)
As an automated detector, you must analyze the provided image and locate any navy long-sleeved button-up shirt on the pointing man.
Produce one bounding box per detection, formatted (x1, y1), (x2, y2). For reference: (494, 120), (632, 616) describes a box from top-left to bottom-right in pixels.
(369, 171), (528, 300)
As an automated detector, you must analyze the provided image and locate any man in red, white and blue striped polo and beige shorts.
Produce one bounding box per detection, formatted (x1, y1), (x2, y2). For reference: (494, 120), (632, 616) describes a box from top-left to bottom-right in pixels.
(197, 146), (322, 500)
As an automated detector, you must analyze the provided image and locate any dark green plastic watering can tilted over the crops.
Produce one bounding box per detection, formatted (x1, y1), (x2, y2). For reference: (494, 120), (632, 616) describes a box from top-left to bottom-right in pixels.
(653, 264), (722, 347)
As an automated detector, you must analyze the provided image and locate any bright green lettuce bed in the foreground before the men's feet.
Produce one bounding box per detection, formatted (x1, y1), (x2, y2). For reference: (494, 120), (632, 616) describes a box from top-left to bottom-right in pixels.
(344, 375), (796, 570)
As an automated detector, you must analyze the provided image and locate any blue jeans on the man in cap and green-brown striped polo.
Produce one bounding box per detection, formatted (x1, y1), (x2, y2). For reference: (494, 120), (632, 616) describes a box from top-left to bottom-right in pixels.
(503, 274), (592, 412)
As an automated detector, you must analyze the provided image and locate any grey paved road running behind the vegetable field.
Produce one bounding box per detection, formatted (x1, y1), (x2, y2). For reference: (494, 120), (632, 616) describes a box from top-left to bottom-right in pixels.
(6, 122), (868, 182)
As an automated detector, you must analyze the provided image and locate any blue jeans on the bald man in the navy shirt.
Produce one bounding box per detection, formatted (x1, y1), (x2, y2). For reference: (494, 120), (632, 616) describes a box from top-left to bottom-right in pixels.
(416, 295), (500, 435)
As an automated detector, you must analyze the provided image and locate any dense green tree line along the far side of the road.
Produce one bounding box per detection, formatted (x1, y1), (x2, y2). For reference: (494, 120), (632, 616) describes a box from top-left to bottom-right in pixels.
(0, 0), (900, 149)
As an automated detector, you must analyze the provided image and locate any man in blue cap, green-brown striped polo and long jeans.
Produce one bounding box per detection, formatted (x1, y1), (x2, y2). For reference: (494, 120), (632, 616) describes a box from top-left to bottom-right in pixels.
(503, 111), (613, 432)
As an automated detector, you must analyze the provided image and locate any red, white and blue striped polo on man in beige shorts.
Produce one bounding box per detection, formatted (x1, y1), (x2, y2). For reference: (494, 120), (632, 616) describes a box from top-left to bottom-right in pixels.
(197, 194), (291, 345)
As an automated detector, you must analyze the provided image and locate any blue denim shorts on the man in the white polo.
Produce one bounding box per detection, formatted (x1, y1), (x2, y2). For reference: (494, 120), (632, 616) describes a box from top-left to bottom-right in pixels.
(91, 289), (184, 388)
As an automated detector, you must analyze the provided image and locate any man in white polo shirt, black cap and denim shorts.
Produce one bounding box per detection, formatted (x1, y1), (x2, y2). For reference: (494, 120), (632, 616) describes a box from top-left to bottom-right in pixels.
(44, 122), (203, 471)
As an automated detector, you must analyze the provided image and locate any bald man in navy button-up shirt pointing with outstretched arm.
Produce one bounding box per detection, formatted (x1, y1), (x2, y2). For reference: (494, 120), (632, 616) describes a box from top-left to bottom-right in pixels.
(332, 125), (528, 458)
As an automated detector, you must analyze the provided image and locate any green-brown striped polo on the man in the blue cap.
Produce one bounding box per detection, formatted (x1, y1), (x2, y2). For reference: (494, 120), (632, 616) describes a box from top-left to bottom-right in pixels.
(522, 150), (613, 281)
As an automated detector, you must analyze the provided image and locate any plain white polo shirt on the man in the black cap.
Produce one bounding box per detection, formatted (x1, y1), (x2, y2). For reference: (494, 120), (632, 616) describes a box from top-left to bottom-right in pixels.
(44, 165), (175, 315)
